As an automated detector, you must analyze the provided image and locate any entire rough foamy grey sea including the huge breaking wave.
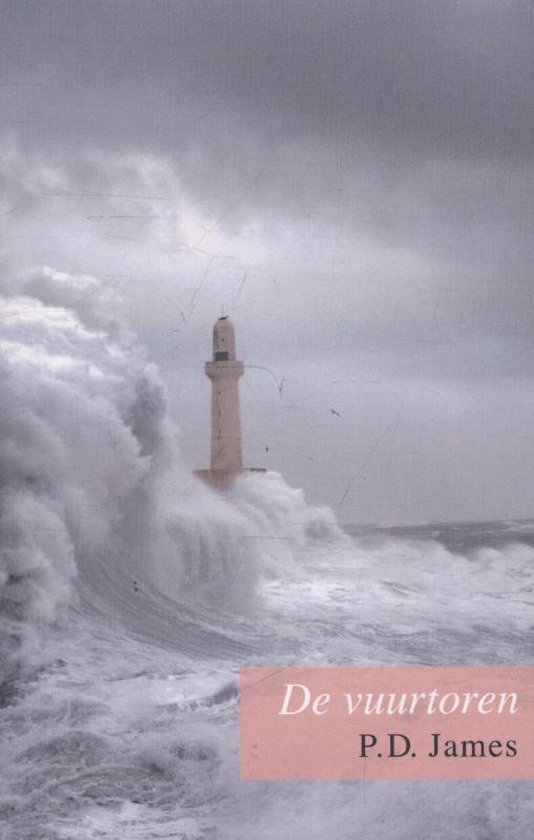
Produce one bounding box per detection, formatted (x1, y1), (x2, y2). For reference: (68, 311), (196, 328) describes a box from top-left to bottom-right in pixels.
(0, 269), (534, 840)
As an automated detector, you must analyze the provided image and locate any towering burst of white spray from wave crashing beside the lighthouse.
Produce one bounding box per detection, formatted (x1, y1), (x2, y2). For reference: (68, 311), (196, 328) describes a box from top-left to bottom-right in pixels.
(0, 268), (338, 676)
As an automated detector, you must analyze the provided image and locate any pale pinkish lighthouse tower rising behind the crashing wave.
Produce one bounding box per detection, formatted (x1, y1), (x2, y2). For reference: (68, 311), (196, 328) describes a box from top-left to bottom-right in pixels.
(195, 315), (265, 490)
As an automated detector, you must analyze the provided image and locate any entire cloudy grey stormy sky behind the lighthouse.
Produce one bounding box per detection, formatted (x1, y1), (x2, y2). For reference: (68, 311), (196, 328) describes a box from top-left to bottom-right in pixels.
(0, 0), (534, 522)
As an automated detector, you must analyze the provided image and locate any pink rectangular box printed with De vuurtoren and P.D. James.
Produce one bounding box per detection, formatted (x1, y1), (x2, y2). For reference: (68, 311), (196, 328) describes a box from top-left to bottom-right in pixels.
(240, 667), (534, 780)
